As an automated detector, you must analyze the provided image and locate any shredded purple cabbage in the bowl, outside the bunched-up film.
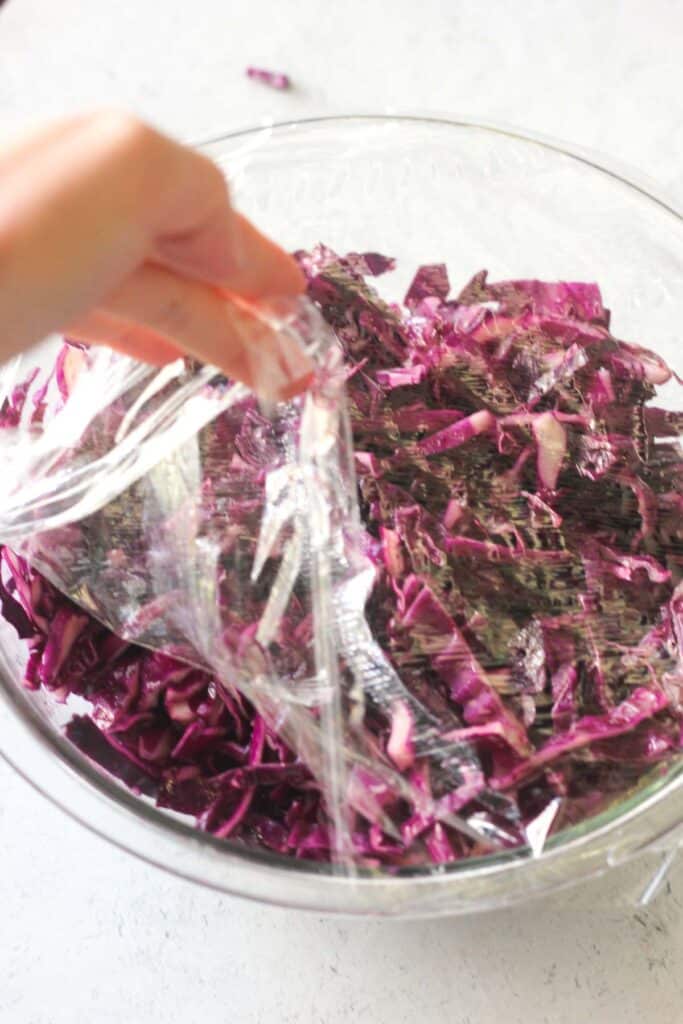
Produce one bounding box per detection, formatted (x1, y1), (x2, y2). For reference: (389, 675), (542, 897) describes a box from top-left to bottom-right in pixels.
(0, 246), (683, 867)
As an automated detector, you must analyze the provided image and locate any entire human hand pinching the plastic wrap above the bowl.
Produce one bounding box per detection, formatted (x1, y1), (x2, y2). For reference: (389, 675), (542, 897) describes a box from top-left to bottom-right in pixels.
(0, 113), (311, 398)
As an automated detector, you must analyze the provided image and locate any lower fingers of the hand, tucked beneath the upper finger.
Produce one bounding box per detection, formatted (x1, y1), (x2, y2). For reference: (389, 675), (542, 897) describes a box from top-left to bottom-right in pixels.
(69, 264), (312, 400)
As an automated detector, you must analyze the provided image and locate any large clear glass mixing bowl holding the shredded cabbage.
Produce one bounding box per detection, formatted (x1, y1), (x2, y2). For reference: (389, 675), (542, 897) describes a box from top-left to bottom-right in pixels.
(0, 116), (683, 916)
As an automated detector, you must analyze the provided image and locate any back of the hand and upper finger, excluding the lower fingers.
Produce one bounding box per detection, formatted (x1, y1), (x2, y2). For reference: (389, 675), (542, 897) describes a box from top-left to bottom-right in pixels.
(0, 114), (303, 356)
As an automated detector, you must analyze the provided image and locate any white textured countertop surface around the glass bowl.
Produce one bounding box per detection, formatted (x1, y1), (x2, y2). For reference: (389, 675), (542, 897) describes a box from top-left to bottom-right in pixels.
(0, 0), (683, 1024)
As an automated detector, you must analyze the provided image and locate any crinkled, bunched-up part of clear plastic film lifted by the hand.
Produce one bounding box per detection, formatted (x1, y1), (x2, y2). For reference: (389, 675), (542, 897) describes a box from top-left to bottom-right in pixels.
(0, 303), (521, 870)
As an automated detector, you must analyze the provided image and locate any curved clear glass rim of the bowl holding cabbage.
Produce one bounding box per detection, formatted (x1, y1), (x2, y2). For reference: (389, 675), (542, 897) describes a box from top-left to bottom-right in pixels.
(0, 113), (683, 916)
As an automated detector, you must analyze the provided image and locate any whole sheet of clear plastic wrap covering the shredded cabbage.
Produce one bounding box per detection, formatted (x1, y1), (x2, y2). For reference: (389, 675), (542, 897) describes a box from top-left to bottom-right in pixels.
(0, 249), (680, 873)
